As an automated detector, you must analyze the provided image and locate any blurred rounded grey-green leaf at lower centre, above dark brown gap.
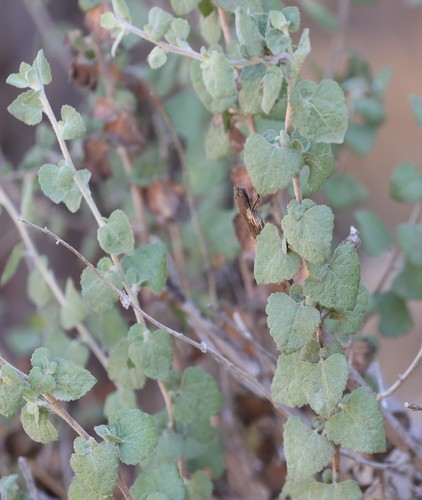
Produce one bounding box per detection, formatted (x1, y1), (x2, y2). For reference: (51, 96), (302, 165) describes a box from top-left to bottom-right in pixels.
(173, 367), (222, 423)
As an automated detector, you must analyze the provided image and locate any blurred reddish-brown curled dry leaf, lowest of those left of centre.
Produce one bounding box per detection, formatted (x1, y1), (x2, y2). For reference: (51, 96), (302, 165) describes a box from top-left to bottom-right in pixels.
(145, 179), (188, 222)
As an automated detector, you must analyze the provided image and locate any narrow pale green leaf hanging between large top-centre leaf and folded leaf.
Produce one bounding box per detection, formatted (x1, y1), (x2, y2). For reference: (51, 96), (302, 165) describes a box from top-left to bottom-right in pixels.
(239, 64), (266, 115)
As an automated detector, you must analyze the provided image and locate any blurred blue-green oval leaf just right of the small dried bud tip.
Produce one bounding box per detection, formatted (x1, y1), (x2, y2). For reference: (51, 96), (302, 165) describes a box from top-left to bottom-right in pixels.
(355, 210), (391, 257)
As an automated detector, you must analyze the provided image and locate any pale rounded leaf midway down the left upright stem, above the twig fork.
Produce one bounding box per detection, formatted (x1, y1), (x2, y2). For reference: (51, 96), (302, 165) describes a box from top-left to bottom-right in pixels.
(97, 209), (135, 255)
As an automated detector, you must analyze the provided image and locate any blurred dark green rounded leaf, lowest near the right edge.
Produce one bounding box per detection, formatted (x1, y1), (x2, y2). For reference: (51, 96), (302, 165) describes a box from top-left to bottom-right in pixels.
(375, 291), (413, 337)
